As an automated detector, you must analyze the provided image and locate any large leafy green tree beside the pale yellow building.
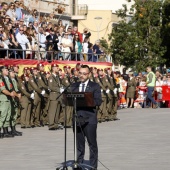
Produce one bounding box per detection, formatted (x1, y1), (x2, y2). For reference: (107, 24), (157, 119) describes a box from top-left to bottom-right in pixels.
(109, 0), (166, 71)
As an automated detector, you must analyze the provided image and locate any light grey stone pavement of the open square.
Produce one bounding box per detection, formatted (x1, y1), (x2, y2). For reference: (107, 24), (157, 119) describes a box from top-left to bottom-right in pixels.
(0, 109), (170, 170)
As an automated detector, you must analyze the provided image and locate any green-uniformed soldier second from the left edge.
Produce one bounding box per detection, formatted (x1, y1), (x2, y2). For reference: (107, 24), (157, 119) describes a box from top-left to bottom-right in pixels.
(9, 68), (22, 136)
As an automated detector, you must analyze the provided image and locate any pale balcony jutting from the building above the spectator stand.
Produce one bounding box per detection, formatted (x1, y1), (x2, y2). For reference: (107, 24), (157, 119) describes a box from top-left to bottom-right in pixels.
(71, 4), (88, 20)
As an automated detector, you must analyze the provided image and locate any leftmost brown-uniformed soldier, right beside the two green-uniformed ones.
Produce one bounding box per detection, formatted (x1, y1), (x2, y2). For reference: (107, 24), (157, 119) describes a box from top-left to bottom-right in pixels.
(20, 74), (34, 128)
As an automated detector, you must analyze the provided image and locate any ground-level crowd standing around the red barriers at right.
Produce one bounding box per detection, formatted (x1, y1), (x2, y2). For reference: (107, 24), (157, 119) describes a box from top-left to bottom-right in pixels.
(117, 70), (170, 109)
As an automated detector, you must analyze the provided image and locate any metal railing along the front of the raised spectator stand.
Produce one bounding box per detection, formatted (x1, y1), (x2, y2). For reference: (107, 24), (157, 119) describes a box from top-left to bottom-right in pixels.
(0, 48), (112, 63)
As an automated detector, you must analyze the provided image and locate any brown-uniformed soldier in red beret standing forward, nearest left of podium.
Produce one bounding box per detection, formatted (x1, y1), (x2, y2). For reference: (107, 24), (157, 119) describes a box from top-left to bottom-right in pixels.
(48, 63), (61, 130)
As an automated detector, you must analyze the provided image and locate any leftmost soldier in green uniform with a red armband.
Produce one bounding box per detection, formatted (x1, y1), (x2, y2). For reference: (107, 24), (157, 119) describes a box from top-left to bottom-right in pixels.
(0, 66), (15, 138)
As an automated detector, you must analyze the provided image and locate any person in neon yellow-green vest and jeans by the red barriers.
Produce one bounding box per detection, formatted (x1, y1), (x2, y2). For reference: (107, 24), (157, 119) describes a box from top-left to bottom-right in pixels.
(146, 66), (158, 109)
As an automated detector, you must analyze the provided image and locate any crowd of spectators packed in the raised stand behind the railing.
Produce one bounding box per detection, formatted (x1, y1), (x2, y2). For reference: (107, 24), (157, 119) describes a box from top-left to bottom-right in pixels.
(0, 1), (105, 62)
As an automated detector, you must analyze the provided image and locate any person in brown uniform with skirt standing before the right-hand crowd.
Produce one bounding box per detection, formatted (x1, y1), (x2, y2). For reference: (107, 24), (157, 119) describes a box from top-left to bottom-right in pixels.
(126, 72), (136, 108)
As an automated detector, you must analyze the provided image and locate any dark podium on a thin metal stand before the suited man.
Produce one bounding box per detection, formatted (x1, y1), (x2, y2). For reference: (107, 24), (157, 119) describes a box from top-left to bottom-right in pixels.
(56, 92), (95, 170)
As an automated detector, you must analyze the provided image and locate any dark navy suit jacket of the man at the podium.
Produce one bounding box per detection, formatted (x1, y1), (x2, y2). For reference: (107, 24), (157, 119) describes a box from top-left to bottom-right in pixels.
(71, 80), (102, 124)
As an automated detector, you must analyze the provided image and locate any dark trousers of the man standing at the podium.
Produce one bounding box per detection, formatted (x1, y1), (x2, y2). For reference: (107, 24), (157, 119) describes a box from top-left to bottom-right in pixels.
(77, 123), (98, 169)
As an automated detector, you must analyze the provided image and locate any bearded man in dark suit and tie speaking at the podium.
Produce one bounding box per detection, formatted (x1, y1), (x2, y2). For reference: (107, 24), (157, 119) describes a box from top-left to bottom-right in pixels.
(72, 65), (102, 169)
